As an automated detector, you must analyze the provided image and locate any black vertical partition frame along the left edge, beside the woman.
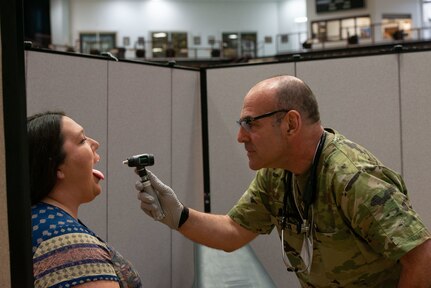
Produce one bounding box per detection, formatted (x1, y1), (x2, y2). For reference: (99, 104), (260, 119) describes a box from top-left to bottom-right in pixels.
(0, 0), (33, 288)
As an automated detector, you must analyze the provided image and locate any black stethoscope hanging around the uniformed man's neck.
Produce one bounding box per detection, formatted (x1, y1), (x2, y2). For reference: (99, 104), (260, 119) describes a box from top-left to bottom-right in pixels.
(281, 131), (326, 273)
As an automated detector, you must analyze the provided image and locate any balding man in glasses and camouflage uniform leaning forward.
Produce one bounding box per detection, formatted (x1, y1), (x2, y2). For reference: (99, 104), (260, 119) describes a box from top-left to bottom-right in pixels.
(137, 76), (431, 288)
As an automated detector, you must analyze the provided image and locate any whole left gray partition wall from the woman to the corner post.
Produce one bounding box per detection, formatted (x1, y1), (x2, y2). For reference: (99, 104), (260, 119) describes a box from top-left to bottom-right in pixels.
(26, 51), (203, 287)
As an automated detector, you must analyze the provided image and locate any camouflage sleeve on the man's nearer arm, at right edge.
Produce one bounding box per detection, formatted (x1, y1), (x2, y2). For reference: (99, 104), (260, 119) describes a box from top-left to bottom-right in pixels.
(339, 166), (430, 260)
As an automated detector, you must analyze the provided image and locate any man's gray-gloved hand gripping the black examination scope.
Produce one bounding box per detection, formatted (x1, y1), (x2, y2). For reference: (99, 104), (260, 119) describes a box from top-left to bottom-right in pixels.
(135, 170), (189, 230)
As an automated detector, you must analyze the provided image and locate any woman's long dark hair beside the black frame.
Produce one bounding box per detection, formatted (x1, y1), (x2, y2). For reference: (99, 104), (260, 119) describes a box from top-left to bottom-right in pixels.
(27, 111), (66, 205)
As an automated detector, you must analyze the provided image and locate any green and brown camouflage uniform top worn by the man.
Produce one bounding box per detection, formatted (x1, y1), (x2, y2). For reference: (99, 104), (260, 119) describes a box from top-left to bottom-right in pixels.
(228, 129), (431, 288)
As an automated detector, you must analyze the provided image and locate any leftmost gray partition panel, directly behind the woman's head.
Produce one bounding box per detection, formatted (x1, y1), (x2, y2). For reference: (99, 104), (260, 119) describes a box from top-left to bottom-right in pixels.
(26, 51), (109, 239)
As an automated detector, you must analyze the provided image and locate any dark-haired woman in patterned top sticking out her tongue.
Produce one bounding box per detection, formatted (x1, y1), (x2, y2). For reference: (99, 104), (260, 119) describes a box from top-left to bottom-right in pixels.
(27, 112), (142, 288)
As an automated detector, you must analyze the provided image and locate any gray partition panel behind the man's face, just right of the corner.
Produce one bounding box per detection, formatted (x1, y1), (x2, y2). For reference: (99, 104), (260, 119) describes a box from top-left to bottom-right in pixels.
(207, 63), (299, 287)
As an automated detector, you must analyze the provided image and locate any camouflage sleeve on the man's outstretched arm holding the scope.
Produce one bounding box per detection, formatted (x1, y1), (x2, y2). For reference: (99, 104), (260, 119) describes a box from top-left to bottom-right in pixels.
(228, 169), (274, 234)
